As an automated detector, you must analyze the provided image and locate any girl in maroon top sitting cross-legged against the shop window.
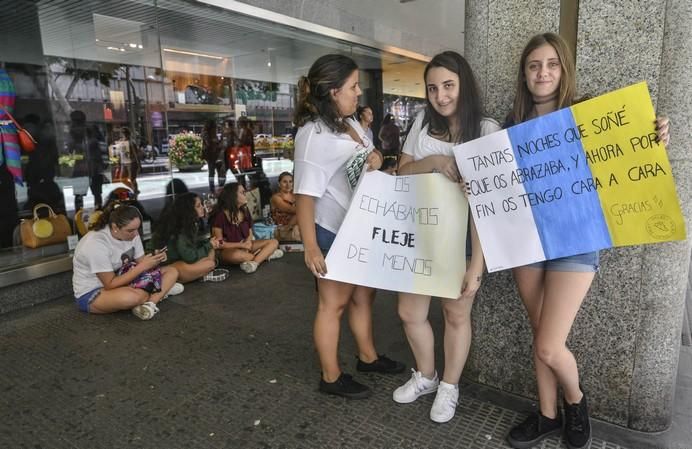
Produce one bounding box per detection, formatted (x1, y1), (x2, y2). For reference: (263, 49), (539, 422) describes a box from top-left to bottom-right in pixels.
(211, 182), (284, 274)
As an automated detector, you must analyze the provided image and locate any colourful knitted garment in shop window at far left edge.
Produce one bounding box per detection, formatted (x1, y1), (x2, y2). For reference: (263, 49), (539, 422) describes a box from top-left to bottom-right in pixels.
(0, 69), (24, 185)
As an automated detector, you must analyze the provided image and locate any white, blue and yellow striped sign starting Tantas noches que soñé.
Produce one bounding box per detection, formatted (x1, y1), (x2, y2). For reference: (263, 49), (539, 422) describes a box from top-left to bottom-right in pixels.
(454, 82), (685, 272)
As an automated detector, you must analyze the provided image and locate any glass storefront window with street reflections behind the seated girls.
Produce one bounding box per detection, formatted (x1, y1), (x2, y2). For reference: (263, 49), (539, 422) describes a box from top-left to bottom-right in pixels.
(0, 0), (425, 267)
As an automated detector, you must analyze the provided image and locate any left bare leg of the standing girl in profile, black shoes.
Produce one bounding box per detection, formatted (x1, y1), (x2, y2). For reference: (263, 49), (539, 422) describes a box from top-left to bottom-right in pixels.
(314, 279), (355, 382)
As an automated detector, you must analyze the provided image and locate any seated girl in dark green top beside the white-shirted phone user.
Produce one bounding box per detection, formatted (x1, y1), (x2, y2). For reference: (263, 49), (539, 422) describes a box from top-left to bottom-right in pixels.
(153, 192), (229, 284)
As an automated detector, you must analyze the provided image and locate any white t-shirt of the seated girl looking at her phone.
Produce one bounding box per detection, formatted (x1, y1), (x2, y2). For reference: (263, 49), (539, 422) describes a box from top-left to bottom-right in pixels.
(72, 226), (144, 298)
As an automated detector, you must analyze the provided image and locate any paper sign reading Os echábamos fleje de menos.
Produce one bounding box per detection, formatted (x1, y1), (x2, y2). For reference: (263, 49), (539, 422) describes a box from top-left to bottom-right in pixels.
(326, 171), (468, 298)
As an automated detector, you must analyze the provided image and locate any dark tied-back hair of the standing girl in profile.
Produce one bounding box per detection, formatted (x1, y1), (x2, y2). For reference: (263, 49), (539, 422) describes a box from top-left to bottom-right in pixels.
(293, 55), (358, 132)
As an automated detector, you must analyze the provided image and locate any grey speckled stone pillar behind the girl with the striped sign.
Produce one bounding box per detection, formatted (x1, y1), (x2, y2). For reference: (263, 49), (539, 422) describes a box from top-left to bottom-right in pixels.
(465, 0), (692, 432)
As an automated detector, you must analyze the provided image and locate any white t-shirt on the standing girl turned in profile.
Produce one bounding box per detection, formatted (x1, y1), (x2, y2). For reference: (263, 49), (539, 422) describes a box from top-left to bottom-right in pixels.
(293, 119), (374, 234)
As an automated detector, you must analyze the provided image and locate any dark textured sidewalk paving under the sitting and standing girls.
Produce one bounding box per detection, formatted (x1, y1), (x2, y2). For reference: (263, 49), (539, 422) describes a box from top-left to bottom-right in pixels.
(0, 253), (692, 449)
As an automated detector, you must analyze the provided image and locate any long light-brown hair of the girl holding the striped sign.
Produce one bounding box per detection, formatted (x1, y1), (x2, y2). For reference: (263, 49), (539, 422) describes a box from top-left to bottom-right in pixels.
(507, 33), (577, 124)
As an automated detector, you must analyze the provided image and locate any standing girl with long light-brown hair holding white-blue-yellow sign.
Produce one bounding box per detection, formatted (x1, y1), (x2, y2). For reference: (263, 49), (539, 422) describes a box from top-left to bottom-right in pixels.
(506, 33), (669, 449)
